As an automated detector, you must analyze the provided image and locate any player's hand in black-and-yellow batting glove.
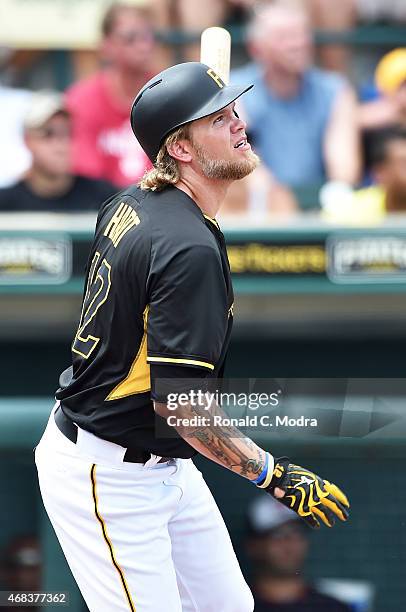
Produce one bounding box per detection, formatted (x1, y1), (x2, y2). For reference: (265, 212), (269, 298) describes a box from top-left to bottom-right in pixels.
(266, 457), (350, 529)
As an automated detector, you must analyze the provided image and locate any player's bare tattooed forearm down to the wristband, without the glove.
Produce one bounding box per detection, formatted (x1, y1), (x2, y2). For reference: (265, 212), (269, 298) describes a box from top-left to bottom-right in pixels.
(155, 396), (272, 480)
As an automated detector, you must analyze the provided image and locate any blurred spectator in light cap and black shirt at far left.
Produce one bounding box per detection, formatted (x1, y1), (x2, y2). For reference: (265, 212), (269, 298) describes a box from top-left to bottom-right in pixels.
(0, 92), (117, 212)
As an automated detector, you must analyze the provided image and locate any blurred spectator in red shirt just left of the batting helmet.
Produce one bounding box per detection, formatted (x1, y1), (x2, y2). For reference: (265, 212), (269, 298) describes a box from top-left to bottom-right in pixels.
(66, 3), (155, 187)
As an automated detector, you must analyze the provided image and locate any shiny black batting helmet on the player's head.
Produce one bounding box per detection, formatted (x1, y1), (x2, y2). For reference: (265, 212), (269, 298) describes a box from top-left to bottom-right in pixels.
(131, 62), (253, 163)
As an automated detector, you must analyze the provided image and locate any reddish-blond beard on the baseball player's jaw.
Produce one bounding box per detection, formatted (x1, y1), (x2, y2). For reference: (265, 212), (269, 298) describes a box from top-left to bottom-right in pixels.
(193, 143), (261, 181)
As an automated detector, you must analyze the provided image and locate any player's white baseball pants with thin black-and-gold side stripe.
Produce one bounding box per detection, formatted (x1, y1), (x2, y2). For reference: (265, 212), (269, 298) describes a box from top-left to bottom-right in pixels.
(35, 411), (254, 612)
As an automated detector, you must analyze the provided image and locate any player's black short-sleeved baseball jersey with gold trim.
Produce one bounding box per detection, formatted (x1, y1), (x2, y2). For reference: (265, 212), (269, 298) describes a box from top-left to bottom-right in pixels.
(56, 186), (234, 458)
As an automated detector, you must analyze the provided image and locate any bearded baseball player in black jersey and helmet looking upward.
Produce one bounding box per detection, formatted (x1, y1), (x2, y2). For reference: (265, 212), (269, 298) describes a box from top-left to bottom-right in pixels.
(36, 62), (348, 612)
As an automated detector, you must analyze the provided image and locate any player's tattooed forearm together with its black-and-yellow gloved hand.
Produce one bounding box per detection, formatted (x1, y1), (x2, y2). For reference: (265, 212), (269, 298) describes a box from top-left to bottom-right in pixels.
(154, 400), (349, 528)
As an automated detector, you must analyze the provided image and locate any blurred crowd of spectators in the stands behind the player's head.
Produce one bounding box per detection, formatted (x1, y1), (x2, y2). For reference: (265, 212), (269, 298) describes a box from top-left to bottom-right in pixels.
(0, 0), (406, 224)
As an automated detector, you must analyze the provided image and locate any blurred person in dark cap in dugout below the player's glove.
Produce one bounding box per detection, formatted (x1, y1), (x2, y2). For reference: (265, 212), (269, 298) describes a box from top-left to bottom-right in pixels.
(247, 496), (349, 612)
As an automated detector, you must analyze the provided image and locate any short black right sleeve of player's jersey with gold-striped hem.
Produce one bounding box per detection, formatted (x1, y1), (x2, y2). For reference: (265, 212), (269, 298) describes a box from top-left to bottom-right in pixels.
(147, 245), (228, 371)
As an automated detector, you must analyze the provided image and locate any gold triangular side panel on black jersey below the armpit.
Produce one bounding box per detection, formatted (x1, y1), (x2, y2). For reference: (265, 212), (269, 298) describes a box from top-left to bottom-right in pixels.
(106, 306), (151, 400)
